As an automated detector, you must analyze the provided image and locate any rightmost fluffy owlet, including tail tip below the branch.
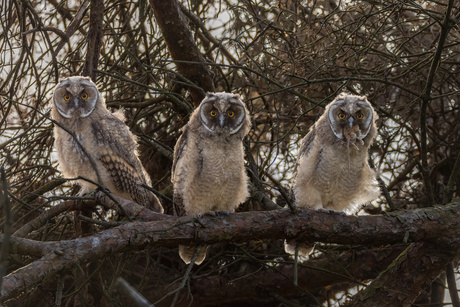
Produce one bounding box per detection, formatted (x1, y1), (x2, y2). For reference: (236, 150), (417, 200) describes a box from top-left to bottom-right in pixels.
(285, 94), (380, 255)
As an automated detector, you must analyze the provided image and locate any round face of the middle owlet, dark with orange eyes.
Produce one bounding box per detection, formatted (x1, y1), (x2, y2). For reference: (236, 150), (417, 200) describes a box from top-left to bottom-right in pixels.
(199, 93), (246, 135)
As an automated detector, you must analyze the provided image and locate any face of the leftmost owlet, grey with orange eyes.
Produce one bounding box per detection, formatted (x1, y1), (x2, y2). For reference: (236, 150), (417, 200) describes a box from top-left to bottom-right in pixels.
(53, 77), (99, 118)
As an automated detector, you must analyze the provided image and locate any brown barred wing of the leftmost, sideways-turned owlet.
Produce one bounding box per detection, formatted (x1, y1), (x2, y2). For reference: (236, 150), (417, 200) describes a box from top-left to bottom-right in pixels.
(92, 117), (163, 212)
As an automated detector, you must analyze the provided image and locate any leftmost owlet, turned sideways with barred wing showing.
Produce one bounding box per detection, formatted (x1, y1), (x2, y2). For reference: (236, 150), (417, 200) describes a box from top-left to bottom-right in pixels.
(52, 77), (163, 212)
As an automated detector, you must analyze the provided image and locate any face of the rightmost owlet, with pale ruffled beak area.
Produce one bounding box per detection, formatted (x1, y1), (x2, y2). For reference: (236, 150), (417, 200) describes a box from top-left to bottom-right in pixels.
(327, 95), (374, 140)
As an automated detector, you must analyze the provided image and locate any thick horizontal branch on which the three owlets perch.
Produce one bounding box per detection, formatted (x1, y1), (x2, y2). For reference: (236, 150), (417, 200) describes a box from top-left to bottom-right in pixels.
(1, 202), (460, 301)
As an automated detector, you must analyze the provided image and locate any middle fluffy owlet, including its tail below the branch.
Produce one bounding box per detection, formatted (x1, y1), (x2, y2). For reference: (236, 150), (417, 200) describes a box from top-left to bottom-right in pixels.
(171, 93), (251, 264)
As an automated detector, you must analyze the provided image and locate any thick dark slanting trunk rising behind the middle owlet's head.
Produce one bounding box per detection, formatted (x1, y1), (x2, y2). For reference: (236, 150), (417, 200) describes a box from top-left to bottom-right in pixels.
(150, 0), (215, 107)
